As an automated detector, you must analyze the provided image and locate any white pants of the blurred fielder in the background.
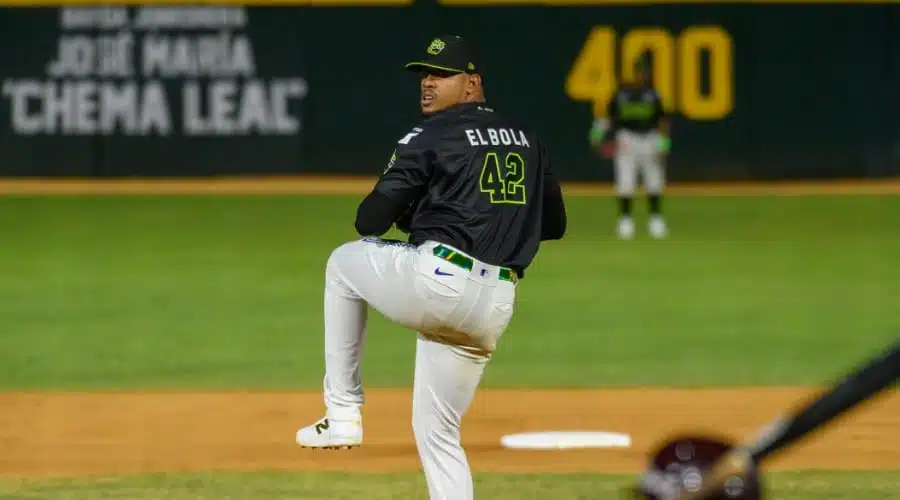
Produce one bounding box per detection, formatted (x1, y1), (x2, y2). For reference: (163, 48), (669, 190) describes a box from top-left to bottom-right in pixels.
(614, 130), (665, 196)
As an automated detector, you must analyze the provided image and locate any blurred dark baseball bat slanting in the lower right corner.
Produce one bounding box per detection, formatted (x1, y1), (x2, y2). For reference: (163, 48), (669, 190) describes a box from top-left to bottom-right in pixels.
(675, 341), (900, 500)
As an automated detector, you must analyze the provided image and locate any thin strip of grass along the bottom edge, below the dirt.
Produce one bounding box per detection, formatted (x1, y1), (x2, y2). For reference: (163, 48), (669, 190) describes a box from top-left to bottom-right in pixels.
(0, 471), (900, 500)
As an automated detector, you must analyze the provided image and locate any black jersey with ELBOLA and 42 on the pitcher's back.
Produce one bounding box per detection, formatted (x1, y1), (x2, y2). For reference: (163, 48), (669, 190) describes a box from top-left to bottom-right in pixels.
(357, 103), (565, 272)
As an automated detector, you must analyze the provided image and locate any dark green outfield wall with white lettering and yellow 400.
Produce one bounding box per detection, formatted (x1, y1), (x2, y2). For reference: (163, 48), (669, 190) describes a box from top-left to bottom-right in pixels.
(0, 0), (900, 181)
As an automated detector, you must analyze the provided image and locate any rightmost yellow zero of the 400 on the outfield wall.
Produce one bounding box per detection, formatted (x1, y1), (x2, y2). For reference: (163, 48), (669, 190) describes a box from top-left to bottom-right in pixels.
(678, 26), (734, 120)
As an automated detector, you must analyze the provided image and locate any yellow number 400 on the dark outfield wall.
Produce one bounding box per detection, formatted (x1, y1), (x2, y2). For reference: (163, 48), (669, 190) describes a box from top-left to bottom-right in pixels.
(566, 26), (734, 120)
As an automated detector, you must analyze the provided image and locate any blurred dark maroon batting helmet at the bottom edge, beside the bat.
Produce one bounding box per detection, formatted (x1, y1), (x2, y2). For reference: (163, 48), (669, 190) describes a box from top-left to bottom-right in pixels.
(634, 436), (761, 500)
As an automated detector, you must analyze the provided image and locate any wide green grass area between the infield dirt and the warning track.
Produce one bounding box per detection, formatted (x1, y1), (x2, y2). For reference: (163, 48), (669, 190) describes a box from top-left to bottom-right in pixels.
(0, 196), (900, 390)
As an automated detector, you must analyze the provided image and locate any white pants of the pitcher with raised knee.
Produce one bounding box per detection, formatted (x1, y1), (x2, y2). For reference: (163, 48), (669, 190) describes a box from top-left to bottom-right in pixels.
(324, 239), (515, 500)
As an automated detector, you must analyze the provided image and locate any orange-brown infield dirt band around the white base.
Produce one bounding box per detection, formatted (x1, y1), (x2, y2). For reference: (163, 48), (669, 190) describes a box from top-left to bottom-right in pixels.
(0, 388), (900, 477)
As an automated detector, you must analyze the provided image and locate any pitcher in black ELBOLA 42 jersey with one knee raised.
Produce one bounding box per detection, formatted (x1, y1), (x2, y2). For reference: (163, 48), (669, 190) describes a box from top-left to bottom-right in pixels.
(296, 36), (566, 500)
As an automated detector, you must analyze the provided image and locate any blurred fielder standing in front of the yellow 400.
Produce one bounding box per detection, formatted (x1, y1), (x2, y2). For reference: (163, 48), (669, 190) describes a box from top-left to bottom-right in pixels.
(590, 59), (671, 239)
